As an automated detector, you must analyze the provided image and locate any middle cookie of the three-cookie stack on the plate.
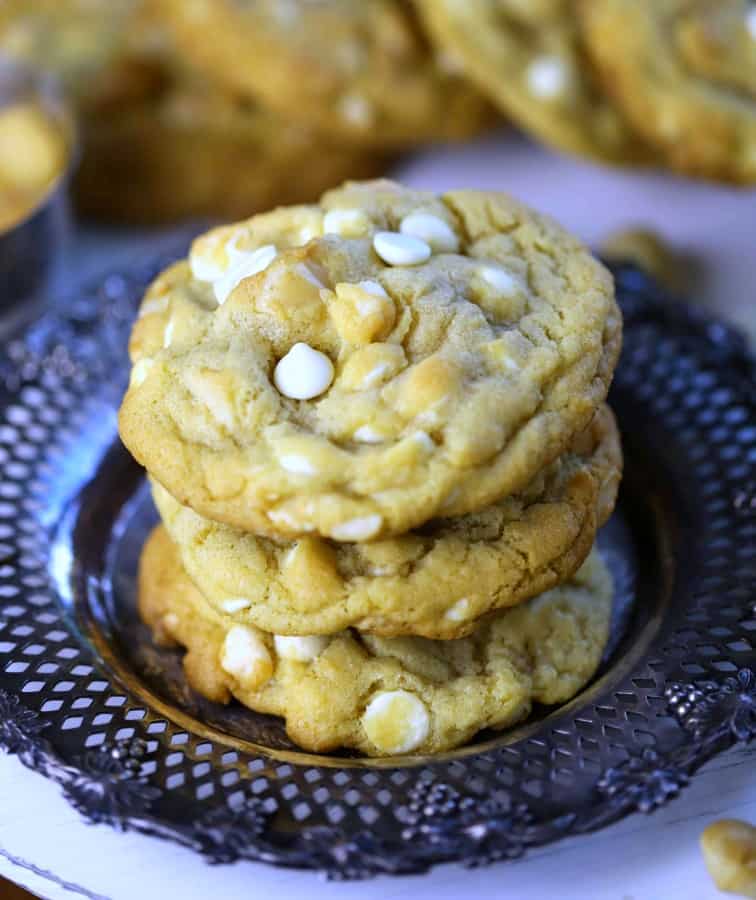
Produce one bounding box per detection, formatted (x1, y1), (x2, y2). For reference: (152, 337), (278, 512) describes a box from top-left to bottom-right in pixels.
(153, 407), (622, 640)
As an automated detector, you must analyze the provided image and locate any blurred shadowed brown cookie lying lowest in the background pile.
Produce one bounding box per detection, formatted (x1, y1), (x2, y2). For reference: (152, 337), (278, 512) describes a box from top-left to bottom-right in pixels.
(74, 76), (386, 223)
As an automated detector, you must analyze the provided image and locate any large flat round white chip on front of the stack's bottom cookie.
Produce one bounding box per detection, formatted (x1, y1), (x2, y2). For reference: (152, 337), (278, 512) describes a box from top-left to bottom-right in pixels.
(362, 690), (430, 755)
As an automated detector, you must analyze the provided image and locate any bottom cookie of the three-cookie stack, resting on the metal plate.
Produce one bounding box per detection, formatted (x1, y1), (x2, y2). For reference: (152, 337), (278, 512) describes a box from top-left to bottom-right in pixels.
(139, 528), (612, 756)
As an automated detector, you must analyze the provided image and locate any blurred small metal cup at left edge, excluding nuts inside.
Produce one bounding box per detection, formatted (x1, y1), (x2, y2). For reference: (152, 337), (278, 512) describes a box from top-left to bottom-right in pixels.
(0, 58), (75, 320)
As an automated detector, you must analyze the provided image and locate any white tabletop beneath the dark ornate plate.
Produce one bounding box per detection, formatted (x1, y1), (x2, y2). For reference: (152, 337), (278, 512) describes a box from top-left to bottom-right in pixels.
(0, 137), (756, 900)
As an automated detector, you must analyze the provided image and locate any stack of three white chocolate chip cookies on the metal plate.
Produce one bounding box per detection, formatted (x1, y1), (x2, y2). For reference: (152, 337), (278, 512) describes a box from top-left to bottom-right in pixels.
(119, 182), (621, 755)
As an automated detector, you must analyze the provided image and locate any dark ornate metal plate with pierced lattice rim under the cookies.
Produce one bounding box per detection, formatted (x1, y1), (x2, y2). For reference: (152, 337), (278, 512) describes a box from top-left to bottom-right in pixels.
(0, 260), (756, 878)
